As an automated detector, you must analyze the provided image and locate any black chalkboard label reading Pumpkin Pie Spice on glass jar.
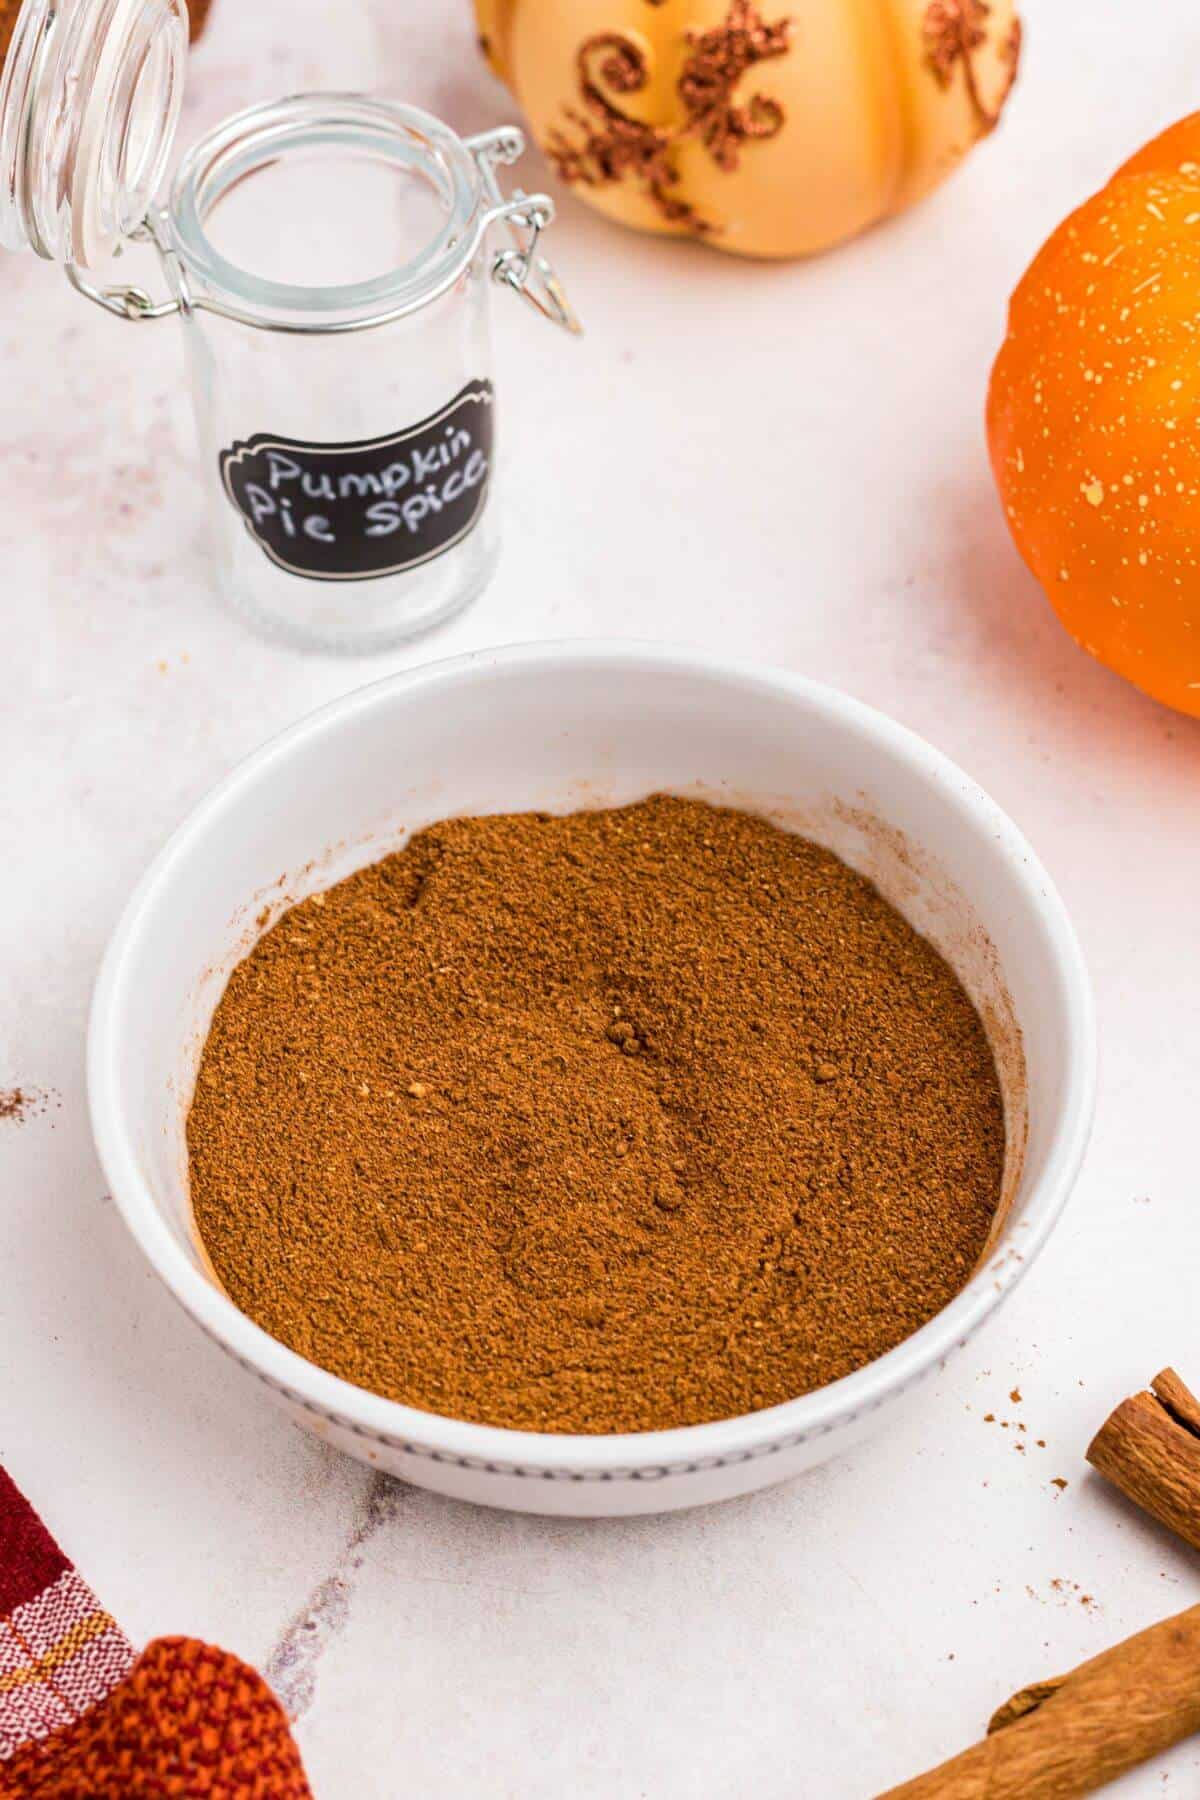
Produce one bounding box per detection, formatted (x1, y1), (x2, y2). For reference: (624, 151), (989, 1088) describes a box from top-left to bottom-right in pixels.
(221, 382), (491, 581)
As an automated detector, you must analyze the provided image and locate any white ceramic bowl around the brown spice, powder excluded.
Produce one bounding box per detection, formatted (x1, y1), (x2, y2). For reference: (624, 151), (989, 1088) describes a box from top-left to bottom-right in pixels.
(88, 643), (1096, 1516)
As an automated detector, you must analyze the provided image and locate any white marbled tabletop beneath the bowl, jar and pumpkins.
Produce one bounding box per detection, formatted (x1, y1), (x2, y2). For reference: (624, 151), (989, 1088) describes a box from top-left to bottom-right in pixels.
(0, 0), (1200, 1800)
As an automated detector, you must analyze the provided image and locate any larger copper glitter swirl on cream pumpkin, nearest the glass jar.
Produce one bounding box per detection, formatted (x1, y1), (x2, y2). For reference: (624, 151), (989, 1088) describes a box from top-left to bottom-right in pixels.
(545, 0), (792, 236)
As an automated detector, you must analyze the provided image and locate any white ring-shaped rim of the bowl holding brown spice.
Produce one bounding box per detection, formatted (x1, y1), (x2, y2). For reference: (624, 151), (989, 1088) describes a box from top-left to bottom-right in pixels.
(88, 641), (1096, 1481)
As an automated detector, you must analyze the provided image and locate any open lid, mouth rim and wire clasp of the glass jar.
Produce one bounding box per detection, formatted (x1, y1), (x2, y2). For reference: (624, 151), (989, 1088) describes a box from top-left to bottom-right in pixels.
(0, 0), (579, 331)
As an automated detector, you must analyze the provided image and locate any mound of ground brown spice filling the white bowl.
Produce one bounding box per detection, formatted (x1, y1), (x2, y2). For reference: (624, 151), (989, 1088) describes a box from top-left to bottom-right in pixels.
(187, 797), (1004, 1431)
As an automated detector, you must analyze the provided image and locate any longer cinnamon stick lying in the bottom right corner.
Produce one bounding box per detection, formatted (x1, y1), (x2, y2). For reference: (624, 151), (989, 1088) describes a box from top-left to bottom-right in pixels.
(878, 1606), (1200, 1800)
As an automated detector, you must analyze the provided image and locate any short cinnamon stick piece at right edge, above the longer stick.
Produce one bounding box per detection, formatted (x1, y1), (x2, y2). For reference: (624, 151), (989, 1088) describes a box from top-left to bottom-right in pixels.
(1087, 1368), (1200, 1550)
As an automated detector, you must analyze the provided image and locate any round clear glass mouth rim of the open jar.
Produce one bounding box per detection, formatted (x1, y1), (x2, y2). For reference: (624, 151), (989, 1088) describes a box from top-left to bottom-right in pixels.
(167, 94), (491, 329)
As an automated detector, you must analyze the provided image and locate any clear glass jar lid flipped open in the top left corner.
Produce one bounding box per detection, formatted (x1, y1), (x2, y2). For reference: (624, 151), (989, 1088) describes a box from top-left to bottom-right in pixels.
(0, 0), (187, 268)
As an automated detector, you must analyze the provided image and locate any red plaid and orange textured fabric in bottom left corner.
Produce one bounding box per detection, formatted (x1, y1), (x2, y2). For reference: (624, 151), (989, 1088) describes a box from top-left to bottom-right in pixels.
(0, 1469), (311, 1800)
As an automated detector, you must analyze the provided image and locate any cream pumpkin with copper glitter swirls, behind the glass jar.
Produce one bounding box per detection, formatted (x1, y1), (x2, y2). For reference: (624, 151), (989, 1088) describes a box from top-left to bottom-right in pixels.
(475, 0), (1020, 257)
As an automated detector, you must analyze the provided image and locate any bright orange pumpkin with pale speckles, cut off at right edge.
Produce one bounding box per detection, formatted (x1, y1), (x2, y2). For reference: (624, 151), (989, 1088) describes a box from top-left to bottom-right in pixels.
(988, 113), (1200, 716)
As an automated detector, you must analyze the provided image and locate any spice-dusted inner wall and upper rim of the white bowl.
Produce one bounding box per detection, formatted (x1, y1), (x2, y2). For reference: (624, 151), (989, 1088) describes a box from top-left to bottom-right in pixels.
(92, 646), (1087, 1418)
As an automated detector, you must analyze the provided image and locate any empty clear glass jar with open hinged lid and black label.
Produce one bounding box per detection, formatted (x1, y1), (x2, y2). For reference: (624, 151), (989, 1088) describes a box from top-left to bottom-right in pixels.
(0, 0), (579, 650)
